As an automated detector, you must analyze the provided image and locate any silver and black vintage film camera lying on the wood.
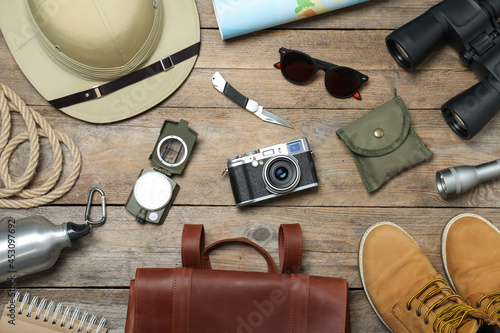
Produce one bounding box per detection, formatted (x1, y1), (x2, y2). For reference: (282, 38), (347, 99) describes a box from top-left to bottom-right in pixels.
(227, 138), (318, 207)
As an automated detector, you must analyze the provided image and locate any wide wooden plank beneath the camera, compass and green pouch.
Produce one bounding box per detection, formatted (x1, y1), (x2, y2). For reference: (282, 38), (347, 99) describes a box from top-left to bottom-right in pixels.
(4, 104), (500, 207)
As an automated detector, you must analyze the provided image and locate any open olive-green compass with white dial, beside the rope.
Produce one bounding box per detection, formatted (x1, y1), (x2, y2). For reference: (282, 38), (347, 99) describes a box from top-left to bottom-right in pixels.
(125, 119), (198, 224)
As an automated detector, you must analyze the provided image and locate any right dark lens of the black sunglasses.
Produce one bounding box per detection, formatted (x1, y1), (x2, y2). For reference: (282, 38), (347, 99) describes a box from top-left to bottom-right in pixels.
(326, 67), (361, 97)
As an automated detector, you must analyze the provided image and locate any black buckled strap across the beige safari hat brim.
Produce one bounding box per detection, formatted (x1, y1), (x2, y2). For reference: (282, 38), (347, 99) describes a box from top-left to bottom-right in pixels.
(49, 42), (200, 109)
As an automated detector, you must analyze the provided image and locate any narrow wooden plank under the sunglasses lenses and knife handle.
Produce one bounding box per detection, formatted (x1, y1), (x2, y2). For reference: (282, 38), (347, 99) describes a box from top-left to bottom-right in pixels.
(0, 69), (478, 110)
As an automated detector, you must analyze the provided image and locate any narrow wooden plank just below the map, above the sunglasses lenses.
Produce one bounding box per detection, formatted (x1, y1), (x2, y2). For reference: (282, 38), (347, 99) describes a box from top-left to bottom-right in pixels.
(196, 30), (464, 70)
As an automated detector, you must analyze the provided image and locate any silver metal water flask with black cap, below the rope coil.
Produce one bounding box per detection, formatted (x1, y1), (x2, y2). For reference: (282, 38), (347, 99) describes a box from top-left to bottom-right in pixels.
(0, 216), (91, 284)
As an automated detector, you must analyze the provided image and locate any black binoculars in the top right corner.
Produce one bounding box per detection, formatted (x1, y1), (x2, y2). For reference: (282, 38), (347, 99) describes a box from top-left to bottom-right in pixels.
(386, 0), (500, 139)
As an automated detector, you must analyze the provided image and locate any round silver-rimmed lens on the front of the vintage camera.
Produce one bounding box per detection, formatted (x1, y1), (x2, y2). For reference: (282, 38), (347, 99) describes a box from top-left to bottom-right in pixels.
(263, 155), (300, 194)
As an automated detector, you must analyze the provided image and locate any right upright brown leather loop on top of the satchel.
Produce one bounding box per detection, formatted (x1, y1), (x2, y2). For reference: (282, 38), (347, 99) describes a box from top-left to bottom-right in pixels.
(279, 223), (302, 274)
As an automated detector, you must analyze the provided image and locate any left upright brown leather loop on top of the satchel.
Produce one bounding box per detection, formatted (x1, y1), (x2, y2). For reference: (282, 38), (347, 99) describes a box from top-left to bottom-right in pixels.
(181, 224), (205, 269)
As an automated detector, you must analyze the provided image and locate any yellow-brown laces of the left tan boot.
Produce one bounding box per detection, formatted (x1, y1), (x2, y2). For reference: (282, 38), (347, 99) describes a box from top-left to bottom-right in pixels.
(406, 278), (476, 333)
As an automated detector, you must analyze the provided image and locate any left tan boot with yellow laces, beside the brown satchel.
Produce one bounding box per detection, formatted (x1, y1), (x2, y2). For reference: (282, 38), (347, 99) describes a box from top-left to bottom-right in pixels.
(359, 222), (488, 333)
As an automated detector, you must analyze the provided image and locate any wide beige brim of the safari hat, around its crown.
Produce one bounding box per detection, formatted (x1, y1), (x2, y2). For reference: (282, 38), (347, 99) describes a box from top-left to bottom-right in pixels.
(0, 0), (200, 123)
